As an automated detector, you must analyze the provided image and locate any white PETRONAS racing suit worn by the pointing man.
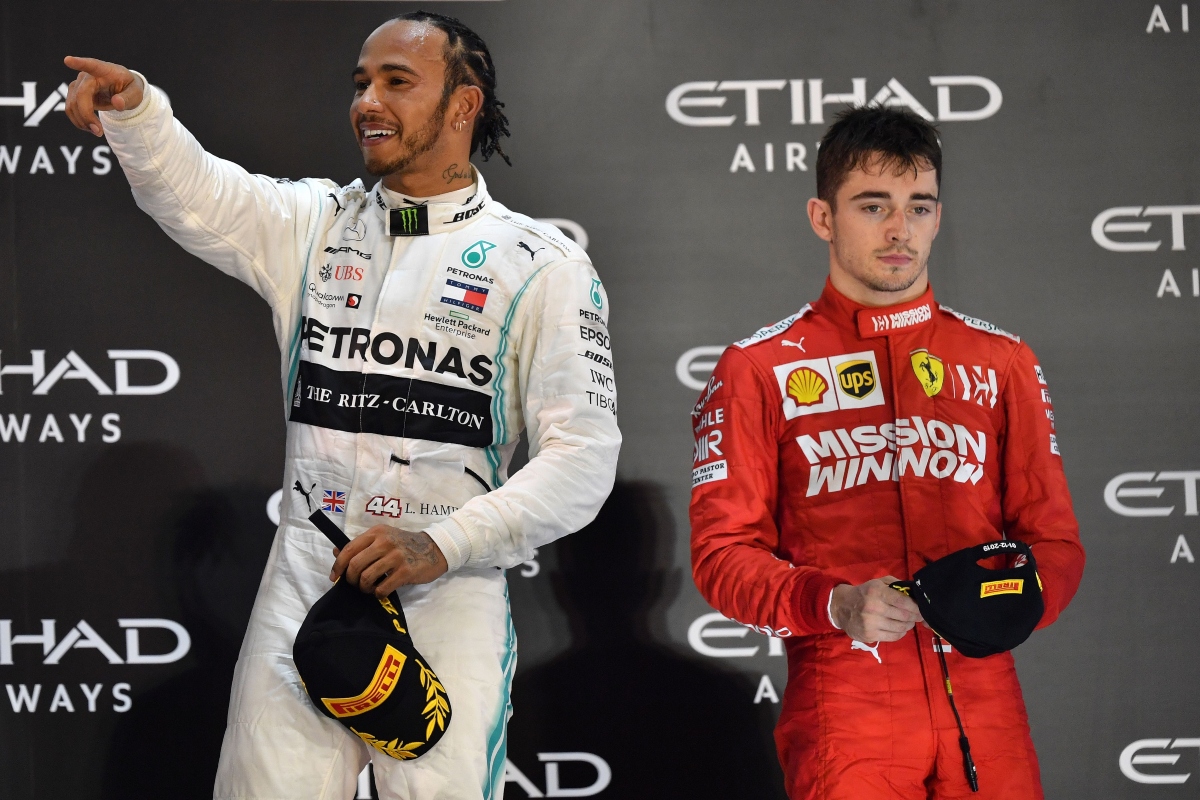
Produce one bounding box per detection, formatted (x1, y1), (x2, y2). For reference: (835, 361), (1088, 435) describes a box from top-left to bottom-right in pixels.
(101, 76), (620, 800)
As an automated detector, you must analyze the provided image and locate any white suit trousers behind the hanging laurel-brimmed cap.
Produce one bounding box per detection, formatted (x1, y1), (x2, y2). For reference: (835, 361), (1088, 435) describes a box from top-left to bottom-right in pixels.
(214, 525), (516, 800)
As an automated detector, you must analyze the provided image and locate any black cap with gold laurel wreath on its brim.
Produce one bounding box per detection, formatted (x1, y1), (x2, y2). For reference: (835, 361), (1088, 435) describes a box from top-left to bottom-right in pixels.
(292, 511), (450, 760)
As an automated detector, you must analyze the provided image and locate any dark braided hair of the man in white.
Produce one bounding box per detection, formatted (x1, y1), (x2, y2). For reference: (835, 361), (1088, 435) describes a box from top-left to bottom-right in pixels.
(392, 11), (512, 167)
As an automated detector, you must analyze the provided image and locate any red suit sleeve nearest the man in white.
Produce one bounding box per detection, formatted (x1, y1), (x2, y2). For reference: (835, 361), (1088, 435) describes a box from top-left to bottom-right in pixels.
(690, 347), (842, 636)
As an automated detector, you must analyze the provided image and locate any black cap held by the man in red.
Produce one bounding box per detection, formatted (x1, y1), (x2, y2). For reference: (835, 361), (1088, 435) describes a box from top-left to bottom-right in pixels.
(892, 540), (1045, 658)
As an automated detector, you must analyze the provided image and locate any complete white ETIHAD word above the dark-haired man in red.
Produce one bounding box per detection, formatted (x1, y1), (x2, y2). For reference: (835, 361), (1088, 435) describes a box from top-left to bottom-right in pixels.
(666, 76), (1004, 127)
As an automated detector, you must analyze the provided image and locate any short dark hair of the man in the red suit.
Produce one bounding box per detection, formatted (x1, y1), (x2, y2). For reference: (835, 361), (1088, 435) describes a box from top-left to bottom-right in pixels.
(817, 106), (942, 205)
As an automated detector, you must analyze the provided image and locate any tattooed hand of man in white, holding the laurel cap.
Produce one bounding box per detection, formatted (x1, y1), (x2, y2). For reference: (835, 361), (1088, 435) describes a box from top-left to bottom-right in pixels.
(329, 525), (446, 597)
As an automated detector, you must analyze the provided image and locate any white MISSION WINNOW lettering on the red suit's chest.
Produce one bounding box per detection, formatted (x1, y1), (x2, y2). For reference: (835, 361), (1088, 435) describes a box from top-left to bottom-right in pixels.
(796, 416), (988, 497)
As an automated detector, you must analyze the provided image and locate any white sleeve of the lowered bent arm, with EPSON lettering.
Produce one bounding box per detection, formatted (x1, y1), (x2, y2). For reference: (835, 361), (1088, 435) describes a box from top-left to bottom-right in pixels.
(426, 260), (620, 570)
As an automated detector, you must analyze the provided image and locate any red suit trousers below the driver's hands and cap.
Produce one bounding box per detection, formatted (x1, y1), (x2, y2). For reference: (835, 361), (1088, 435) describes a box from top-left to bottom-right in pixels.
(775, 625), (1042, 800)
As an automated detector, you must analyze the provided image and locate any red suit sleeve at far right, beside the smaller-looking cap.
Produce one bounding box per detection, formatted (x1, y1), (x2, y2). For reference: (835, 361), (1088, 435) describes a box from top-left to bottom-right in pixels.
(1000, 343), (1084, 627)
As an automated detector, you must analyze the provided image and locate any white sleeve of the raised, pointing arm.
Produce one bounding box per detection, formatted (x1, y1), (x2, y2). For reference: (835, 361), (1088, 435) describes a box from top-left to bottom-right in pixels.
(100, 76), (332, 307)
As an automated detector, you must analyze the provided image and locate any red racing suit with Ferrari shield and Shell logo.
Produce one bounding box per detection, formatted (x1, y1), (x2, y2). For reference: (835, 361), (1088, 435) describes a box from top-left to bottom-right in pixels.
(691, 284), (1084, 800)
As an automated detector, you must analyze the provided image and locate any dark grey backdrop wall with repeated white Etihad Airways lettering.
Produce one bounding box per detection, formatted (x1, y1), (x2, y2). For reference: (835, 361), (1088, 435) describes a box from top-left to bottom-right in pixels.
(0, 0), (1200, 799)
